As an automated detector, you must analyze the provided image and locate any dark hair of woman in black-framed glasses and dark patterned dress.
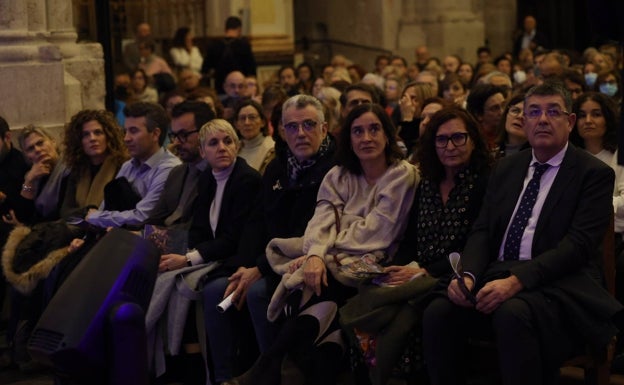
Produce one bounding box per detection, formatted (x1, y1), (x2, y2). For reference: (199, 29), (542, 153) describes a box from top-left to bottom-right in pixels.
(417, 106), (492, 183)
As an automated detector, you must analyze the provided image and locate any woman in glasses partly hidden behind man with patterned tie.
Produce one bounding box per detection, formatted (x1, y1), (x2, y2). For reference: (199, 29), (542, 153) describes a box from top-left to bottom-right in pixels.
(496, 94), (527, 158)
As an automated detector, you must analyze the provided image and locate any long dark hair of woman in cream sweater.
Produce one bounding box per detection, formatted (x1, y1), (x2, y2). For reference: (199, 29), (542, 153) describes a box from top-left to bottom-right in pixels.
(336, 103), (403, 175)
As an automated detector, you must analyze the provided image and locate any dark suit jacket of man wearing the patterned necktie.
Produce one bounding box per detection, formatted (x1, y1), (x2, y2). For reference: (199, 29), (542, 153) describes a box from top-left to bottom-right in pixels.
(462, 144), (614, 289)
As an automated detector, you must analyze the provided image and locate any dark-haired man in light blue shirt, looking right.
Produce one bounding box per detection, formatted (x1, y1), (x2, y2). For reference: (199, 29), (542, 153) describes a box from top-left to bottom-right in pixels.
(85, 102), (180, 228)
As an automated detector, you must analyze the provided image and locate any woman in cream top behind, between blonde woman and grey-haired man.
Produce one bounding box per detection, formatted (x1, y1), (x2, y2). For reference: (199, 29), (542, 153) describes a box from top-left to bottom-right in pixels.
(234, 99), (275, 174)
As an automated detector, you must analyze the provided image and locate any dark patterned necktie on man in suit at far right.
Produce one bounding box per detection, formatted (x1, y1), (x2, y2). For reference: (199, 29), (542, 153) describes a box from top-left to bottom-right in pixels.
(503, 162), (550, 260)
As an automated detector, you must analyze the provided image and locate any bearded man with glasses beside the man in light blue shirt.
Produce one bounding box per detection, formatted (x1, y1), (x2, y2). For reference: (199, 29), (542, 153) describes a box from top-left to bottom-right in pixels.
(147, 101), (215, 229)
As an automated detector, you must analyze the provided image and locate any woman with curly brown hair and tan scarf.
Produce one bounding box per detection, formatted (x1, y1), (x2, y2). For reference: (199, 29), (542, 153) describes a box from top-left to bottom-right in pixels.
(61, 110), (129, 216)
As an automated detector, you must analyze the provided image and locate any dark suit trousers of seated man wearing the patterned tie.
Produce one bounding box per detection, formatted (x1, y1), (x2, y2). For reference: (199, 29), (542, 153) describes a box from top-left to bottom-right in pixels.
(423, 297), (559, 385)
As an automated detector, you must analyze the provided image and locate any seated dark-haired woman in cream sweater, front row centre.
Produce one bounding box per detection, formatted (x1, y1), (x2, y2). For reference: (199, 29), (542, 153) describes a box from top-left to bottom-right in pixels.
(235, 104), (418, 385)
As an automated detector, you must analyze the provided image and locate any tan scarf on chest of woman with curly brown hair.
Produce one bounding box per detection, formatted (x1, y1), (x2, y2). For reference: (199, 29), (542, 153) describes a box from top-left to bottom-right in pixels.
(76, 156), (119, 207)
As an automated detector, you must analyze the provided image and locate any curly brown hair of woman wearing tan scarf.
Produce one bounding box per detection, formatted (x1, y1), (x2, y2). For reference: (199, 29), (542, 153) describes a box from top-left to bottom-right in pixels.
(63, 110), (130, 171)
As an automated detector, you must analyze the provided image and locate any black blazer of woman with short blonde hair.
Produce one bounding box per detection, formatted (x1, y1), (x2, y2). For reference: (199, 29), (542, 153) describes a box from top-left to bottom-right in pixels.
(189, 157), (262, 272)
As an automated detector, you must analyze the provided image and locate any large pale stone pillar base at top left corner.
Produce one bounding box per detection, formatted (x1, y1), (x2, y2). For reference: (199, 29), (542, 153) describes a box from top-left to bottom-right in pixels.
(0, 0), (104, 133)
